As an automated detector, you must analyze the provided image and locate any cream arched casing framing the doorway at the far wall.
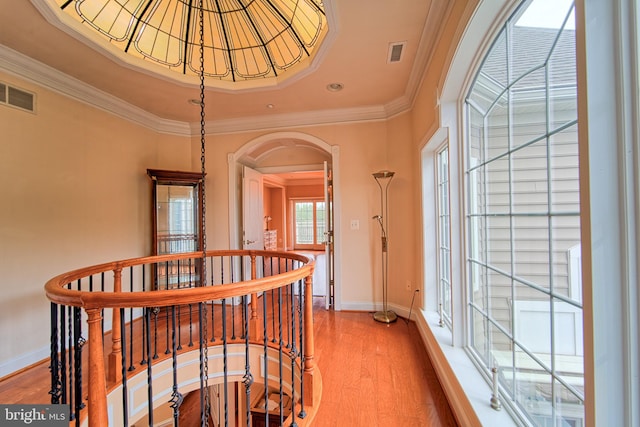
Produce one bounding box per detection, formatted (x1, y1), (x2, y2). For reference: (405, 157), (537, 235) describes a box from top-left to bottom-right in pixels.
(227, 132), (342, 311)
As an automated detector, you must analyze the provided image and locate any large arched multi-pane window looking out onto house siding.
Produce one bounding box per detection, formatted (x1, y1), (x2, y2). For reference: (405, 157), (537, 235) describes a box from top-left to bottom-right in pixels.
(465, 0), (584, 426)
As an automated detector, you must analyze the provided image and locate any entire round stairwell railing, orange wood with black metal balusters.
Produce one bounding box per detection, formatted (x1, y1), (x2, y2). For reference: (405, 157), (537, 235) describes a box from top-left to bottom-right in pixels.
(45, 250), (318, 426)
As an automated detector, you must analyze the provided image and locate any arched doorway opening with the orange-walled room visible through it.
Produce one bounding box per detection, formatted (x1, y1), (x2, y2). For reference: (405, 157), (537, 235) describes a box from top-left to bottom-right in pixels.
(228, 132), (341, 310)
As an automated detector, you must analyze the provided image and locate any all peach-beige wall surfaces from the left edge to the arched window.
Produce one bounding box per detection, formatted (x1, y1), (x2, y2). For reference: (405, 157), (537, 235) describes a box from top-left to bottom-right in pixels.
(0, 2), (470, 375)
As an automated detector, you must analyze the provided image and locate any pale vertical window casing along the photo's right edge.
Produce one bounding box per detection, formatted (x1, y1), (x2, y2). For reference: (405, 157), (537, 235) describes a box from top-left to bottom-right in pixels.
(576, 0), (640, 426)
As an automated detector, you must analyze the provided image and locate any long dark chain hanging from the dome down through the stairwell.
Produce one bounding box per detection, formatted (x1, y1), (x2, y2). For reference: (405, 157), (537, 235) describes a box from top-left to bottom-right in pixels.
(198, 0), (211, 427)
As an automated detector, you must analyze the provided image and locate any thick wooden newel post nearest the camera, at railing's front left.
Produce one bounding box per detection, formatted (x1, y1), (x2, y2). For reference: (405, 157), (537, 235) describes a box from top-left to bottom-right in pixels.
(87, 308), (109, 427)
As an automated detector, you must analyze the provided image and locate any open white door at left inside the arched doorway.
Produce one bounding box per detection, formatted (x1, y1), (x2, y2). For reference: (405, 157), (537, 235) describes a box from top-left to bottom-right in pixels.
(242, 166), (264, 249)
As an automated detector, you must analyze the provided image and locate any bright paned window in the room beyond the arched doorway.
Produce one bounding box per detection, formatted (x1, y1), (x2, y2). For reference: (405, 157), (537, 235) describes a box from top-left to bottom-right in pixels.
(293, 200), (326, 249)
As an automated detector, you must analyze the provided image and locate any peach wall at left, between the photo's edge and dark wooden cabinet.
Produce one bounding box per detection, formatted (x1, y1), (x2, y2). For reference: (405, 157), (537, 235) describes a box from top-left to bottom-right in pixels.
(0, 73), (192, 376)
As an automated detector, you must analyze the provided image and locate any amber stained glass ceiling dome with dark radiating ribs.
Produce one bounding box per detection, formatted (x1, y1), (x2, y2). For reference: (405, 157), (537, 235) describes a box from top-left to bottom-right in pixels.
(51, 0), (328, 87)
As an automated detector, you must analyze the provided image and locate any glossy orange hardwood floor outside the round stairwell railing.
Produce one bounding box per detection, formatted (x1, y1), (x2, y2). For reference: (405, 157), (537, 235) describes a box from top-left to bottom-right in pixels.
(0, 300), (457, 427)
